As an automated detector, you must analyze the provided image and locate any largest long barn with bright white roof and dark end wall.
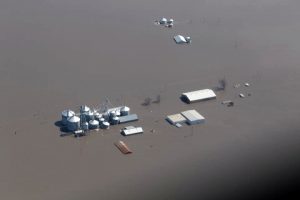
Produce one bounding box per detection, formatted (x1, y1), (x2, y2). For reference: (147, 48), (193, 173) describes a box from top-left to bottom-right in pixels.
(182, 89), (217, 103)
